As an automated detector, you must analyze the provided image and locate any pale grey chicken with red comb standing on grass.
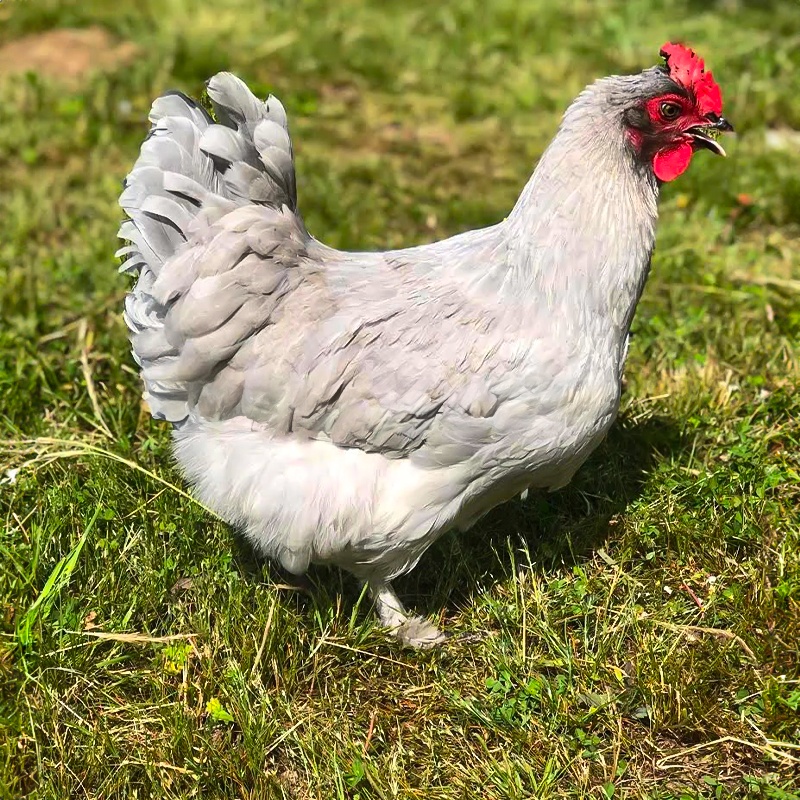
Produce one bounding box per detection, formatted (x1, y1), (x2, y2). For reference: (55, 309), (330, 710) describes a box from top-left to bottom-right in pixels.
(119, 44), (732, 647)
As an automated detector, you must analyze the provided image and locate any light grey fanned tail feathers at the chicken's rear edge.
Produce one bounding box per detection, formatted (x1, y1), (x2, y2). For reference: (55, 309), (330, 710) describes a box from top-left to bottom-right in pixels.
(117, 73), (297, 423)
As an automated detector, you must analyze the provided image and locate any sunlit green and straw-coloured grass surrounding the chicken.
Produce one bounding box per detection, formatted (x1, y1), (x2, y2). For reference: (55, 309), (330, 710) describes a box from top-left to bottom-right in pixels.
(0, 0), (800, 800)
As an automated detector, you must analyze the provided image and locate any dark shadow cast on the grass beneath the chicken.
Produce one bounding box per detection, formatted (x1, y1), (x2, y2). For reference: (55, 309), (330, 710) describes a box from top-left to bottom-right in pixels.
(228, 417), (690, 632)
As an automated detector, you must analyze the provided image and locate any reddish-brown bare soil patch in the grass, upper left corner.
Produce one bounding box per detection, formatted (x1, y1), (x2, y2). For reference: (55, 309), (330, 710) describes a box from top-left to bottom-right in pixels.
(0, 25), (138, 84)
